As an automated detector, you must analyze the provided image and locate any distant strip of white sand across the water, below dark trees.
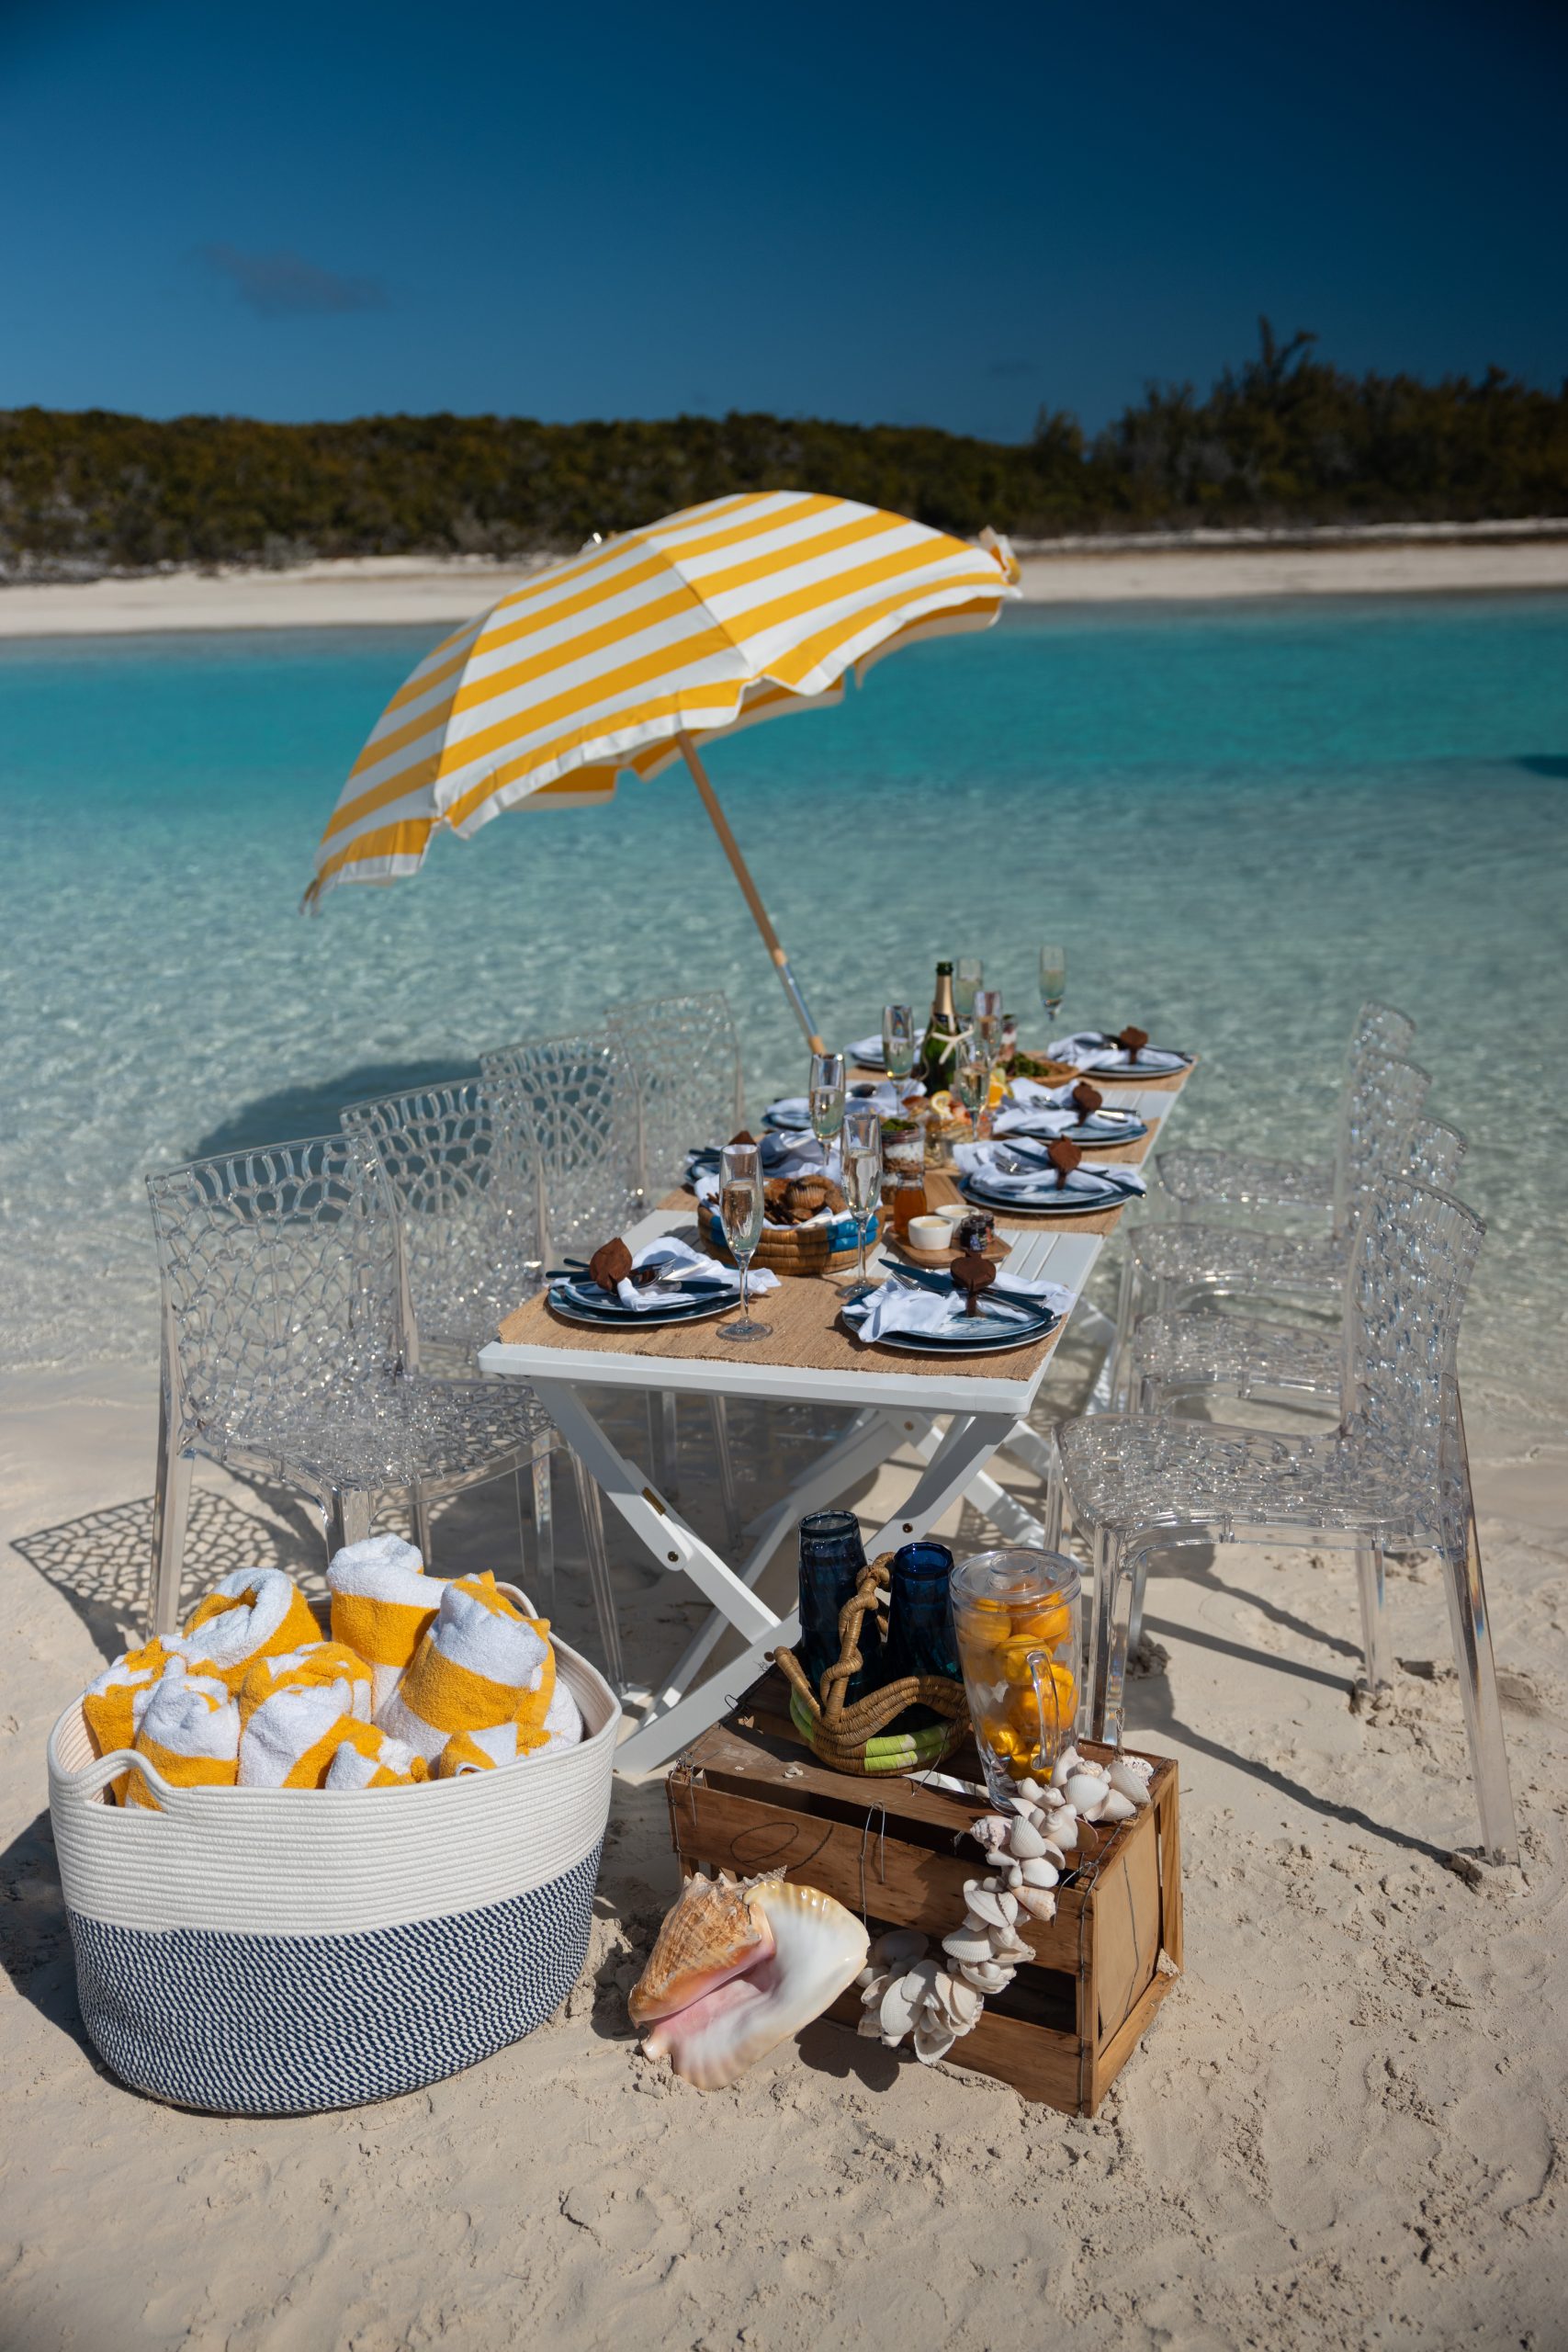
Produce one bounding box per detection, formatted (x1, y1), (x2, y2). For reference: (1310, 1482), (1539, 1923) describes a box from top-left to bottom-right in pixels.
(0, 537), (1568, 638)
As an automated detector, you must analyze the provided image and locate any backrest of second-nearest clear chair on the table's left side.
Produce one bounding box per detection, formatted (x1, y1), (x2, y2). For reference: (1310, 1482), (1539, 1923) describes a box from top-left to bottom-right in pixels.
(344, 1077), (543, 1360)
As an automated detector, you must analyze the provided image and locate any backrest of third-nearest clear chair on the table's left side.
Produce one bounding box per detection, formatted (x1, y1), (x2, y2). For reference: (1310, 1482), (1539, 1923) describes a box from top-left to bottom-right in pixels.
(479, 1037), (644, 1259)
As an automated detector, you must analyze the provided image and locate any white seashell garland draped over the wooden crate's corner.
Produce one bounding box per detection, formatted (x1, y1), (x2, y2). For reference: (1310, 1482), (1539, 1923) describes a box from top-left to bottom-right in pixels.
(856, 1747), (1155, 2065)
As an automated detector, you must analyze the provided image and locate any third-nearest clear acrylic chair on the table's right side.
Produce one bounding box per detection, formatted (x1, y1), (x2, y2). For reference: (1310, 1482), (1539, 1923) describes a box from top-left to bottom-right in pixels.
(1110, 1054), (1432, 1404)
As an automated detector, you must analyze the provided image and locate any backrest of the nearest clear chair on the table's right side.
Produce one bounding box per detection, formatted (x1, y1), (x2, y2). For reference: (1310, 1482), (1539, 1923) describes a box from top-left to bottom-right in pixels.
(1345, 1176), (1485, 1510)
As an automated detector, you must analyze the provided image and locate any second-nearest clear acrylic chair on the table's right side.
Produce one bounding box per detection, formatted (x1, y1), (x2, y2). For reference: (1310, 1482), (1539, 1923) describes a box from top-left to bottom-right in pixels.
(1134, 1120), (1467, 1414)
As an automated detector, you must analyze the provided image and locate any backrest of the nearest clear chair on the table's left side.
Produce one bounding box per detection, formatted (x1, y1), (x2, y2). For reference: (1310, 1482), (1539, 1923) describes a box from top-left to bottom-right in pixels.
(148, 1136), (407, 1444)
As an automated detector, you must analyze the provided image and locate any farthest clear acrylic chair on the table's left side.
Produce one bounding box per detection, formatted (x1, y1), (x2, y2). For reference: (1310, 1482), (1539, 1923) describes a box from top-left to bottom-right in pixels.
(604, 990), (745, 1536)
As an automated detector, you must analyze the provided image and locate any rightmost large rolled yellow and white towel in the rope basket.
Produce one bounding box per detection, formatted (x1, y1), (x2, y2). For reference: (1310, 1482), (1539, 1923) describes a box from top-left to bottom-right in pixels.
(376, 1571), (555, 1761)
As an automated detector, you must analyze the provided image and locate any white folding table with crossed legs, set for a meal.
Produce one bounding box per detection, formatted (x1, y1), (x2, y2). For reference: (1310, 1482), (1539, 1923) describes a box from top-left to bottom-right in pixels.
(479, 1087), (1180, 1771)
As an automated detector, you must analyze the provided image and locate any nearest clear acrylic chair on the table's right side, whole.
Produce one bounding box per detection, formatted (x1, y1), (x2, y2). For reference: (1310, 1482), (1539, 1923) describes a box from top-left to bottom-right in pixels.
(1060, 1179), (1517, 1860)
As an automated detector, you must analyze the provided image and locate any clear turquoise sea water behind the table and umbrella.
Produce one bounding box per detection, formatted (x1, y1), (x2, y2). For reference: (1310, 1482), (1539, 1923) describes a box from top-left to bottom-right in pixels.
(0, 597), (1568, 1407)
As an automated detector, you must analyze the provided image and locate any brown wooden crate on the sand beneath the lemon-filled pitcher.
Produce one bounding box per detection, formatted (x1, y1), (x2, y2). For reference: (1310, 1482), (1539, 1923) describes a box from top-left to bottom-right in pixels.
(668, 1672), (1182, 2114)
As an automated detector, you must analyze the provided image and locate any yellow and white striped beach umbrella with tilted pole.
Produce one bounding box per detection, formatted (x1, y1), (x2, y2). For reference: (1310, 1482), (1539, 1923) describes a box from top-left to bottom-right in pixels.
(306, 489), (1018, 1044)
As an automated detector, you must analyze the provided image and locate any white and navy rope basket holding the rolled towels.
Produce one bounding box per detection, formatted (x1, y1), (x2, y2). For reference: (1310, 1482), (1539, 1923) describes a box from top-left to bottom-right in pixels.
(50, 1642), (621, 2114)
